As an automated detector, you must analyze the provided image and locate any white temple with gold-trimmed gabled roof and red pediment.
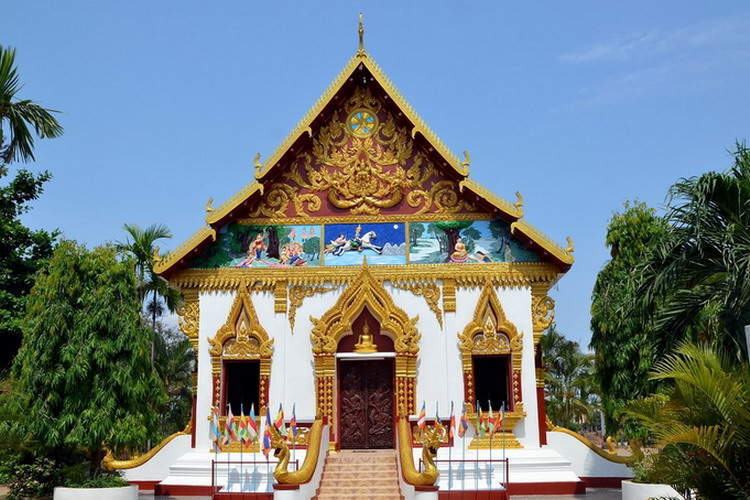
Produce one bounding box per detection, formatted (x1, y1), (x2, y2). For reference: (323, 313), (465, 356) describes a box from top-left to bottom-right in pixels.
(106, 20), (632, 499)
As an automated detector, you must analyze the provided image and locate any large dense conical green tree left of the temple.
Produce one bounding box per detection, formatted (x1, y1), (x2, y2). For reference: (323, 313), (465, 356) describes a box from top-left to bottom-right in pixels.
(13, 241), (164, 474)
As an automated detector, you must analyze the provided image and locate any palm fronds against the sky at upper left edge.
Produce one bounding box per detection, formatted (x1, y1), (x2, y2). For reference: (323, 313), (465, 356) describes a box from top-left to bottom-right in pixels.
(0, 45), (63, 164)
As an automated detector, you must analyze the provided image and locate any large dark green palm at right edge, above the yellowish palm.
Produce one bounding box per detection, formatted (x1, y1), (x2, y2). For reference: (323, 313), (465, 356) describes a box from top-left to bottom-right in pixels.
(641, 144), (750, 359)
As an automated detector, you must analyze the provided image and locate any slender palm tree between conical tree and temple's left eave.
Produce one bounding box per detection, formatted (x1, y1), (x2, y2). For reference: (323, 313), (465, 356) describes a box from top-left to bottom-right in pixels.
(117, 224), (182, 363)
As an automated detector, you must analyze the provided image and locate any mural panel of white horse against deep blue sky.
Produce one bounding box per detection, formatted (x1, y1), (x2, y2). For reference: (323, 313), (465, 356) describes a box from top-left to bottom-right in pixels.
(323, 222), (406, 266)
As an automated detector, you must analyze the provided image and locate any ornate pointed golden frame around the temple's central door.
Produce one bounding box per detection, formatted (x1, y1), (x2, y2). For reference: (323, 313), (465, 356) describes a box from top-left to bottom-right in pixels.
(310, 264), (422, 441)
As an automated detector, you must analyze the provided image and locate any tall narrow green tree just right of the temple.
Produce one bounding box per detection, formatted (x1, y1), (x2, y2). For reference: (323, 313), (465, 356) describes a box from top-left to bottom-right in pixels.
(590, 202), (667, 435)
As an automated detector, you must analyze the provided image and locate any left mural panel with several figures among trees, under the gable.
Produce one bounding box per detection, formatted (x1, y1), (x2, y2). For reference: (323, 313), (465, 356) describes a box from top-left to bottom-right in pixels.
(190, 223), (320, 268)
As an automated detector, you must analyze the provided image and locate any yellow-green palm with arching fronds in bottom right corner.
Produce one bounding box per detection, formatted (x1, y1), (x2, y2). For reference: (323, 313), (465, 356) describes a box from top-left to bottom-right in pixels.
(625, 344), (750, 500)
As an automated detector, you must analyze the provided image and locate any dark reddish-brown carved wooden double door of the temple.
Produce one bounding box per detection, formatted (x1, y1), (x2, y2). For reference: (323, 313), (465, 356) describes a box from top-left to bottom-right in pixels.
(339, 360), (393, 449)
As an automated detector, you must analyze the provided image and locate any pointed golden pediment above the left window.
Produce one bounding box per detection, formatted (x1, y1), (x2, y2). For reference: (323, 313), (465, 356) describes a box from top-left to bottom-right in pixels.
(208, 287), (273, 373)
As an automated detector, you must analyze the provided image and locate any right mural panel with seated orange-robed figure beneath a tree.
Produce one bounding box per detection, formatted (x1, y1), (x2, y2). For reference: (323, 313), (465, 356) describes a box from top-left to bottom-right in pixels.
(409, 219), (539, 264)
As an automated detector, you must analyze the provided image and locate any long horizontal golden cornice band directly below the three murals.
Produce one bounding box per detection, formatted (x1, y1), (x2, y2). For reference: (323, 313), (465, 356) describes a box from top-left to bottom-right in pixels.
(170, 262), (560, 292)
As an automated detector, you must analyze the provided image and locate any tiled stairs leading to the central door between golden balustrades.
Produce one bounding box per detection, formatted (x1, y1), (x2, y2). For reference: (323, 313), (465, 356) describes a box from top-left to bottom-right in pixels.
(314, 450), (403, 500)
